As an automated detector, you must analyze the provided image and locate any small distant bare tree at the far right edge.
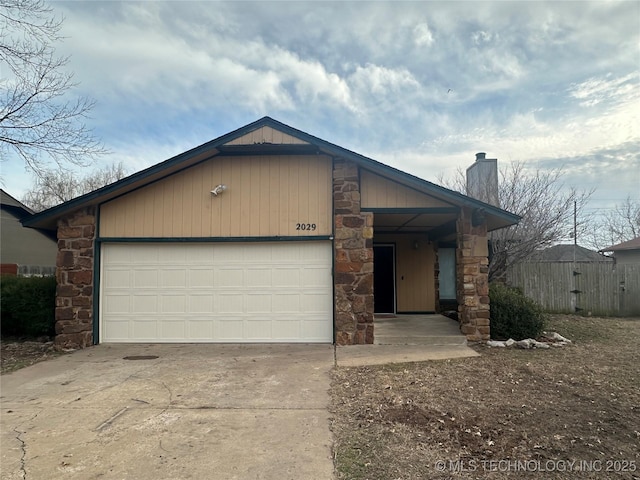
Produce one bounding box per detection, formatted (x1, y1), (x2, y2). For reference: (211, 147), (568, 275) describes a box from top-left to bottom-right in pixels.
(591, 196), (640, 250)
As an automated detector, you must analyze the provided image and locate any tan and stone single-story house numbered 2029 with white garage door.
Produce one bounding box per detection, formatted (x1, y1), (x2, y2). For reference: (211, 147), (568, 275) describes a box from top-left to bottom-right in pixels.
(24, 117), (519, 347)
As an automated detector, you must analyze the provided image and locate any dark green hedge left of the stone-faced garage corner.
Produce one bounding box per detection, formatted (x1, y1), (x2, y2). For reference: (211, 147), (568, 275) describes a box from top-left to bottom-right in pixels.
(0, 276), (56, 337)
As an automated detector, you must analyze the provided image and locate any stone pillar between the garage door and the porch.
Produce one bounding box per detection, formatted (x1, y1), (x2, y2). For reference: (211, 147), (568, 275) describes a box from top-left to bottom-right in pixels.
(333, 160), (373, 345)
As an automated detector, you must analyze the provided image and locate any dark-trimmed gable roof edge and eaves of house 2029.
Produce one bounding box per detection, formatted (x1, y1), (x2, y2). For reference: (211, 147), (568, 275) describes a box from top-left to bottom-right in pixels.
(23, 117), (520, 230)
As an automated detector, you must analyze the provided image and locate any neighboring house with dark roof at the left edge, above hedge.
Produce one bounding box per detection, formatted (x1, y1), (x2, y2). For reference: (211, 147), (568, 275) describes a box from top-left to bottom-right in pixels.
(0, 190), (58, 275)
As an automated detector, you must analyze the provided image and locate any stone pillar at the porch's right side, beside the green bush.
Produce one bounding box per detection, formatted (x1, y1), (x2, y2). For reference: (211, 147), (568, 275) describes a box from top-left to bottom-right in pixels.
(456, 208), (490, 341)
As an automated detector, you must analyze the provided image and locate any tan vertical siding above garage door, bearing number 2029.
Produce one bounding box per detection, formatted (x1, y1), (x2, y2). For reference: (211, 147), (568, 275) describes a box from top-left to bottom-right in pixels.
(100, 156), (332, 238)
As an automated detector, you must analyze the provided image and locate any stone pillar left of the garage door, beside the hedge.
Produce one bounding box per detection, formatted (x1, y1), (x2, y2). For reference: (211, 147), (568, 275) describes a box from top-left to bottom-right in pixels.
(55, 207), (96, 348)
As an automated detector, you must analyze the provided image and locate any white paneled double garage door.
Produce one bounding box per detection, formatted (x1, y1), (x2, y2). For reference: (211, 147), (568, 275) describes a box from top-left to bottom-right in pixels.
(100, 242), (333, 343)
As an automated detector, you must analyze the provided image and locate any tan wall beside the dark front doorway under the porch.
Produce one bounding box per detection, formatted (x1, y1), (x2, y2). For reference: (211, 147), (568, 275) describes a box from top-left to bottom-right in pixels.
(374, 235), (436, 313)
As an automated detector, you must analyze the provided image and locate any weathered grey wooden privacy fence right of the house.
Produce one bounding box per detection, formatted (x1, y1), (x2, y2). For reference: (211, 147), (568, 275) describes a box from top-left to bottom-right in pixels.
(507, 262), (640, 316)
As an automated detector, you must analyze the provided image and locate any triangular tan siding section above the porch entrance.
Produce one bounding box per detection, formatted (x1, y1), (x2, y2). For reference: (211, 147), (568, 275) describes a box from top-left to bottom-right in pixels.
(360, 170), (452, 209)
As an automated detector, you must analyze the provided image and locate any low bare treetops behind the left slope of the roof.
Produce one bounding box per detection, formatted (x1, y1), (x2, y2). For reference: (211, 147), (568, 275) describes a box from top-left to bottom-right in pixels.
(22, 163), (126, 212)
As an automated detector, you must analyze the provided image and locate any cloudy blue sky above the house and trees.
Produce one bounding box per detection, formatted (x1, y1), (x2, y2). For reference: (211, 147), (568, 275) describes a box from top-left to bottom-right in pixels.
(1, 1), (640, 229)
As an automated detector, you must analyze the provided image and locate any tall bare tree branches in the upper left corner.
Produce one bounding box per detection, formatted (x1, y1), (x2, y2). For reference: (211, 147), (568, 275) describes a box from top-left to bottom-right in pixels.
(0, 0), (104, 174)
